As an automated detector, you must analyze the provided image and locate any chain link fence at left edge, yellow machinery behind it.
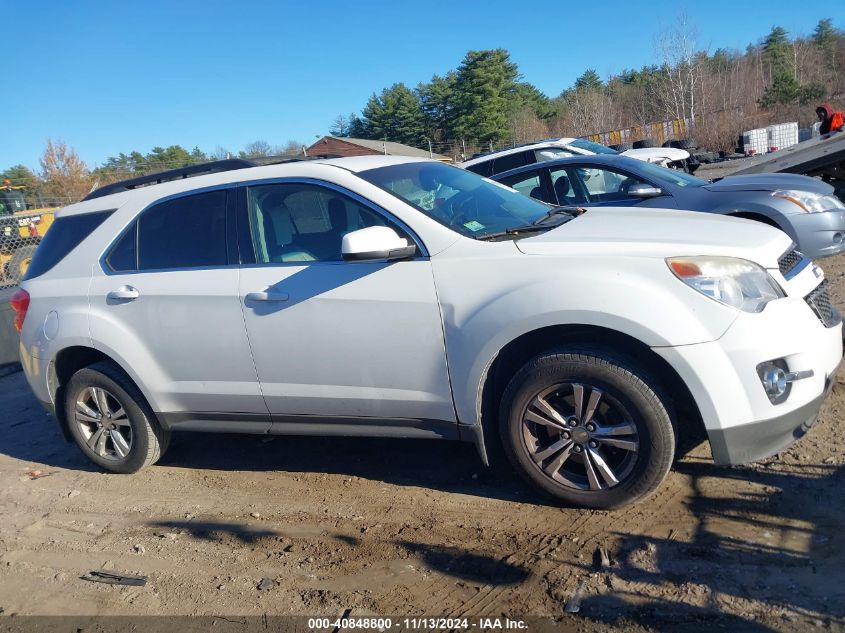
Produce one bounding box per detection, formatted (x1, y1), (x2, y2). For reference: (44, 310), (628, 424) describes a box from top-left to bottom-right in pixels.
(0, 209), (56, 288)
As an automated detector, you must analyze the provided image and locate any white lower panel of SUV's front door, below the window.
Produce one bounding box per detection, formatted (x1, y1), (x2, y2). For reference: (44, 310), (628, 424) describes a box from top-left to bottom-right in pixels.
(239, 260), (455, 422)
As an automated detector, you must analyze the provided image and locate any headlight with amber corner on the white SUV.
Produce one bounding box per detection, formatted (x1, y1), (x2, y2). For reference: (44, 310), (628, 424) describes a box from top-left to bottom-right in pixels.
(666, 257), (786, 312)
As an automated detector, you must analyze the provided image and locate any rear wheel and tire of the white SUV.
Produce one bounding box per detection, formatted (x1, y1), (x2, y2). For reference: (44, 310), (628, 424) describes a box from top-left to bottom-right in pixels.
(64, 362), (170, 473)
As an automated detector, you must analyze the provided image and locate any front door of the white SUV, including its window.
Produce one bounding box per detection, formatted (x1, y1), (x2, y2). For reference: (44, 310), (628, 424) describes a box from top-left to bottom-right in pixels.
(238, 181), (456, 432)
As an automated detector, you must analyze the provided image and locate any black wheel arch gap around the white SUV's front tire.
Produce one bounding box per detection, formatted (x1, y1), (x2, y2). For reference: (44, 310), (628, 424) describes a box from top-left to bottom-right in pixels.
(476, 324), (707, 463)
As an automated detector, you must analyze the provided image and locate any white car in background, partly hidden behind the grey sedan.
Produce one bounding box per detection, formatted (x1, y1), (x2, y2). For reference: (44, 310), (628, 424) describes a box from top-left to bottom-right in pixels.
(460, 138), (690, 176)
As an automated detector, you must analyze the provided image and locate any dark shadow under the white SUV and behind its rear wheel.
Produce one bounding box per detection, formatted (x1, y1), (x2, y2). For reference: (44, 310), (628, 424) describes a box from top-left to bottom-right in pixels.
(0, 374), (540, 505)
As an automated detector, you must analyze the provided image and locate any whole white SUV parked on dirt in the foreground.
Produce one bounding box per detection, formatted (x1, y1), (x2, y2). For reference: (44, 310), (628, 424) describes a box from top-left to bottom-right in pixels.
(12, 156), (842, 508)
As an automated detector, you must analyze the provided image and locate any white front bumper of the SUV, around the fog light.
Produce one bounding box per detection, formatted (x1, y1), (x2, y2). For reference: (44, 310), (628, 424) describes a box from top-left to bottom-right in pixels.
(653, 286), (843, 464)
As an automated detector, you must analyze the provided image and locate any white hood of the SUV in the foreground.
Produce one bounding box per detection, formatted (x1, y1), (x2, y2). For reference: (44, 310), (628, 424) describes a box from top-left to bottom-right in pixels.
(515, 207), (792, 268)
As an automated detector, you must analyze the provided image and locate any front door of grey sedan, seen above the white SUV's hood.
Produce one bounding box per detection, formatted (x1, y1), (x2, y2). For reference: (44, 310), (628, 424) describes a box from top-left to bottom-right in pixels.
(567, 165), (675, 207)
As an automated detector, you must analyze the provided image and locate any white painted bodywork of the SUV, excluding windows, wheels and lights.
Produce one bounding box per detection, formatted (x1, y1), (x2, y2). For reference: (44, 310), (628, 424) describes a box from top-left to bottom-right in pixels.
(16, 154), (842, 474)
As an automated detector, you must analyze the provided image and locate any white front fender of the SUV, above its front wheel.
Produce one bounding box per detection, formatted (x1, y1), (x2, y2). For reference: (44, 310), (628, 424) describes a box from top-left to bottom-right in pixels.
(435, 257), (737, 425)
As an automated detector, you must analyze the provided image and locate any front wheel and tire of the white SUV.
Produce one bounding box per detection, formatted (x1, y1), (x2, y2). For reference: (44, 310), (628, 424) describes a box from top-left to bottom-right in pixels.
(499, 347), (675, 510)
